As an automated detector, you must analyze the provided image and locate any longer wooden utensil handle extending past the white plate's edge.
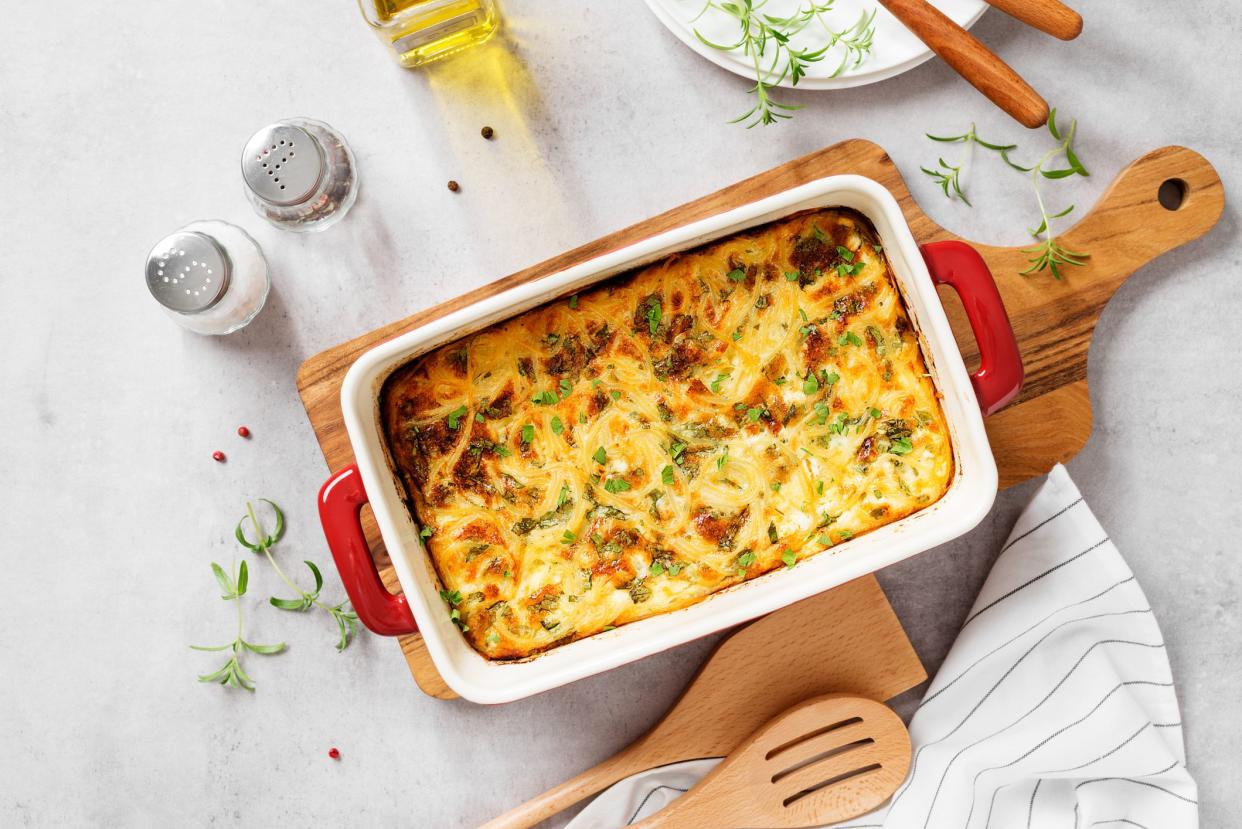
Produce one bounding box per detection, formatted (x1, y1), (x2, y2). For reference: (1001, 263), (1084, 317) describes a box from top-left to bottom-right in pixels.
(879, 0), (1048, 128)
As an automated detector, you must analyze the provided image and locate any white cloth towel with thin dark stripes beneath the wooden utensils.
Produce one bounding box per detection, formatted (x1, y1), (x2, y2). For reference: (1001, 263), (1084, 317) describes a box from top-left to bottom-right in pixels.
(566, 466), (1199, 829)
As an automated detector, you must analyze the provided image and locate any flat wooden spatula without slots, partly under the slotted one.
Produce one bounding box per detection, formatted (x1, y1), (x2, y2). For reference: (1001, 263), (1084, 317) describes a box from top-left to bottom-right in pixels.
(483, 575), (927, 829)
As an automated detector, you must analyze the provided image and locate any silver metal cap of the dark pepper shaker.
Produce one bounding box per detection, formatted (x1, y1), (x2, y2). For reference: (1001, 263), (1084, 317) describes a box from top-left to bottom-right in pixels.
(241, 123), (328, 206)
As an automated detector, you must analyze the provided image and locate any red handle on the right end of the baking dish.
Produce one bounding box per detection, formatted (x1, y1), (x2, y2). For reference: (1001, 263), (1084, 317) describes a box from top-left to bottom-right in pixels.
(919, 241), (1023, 418)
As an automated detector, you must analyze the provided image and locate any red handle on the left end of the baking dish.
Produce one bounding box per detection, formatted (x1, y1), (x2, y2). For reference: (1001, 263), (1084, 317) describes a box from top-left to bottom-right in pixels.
(319, 464), (419, 636)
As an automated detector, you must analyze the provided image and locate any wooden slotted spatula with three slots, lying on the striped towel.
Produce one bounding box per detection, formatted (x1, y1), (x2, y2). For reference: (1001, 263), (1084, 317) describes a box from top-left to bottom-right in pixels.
(635, 694), (910, 829)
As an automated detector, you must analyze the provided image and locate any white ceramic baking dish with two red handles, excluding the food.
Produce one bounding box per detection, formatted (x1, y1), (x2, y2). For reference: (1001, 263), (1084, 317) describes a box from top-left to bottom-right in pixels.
(319, 175), (1022, 703)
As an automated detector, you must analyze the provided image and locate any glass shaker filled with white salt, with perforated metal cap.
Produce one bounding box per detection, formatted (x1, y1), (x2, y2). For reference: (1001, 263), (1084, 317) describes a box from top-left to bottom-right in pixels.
(147, 220), (270, 334)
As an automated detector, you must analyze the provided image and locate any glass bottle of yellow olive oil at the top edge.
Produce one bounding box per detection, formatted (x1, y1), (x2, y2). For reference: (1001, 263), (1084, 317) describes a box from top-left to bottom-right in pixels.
(358, 0), (501, 68)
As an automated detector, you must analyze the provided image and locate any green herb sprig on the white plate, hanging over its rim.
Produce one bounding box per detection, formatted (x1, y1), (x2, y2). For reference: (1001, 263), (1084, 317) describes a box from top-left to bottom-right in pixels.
(694, 0), (876, 129)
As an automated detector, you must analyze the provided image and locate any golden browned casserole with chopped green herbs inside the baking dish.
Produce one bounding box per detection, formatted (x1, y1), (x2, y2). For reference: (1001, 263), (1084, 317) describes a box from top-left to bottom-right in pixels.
(381, 210), (953, 659)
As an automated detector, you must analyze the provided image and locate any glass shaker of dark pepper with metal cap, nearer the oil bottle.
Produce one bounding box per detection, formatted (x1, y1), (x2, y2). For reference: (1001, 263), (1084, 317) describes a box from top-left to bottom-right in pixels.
(241, 118), (358, 232)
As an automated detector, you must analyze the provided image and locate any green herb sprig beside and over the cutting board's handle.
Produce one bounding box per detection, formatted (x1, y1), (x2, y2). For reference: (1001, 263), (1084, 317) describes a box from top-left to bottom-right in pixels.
(920, 109), (1090, 280)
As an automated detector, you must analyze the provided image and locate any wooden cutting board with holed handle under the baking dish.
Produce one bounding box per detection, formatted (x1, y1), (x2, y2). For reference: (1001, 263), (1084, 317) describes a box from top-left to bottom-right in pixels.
(297, 139), (1225, 698)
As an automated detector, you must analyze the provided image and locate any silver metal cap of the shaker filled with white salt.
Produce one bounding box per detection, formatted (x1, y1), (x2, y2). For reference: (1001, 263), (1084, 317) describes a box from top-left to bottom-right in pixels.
(147, 230), (232, 313)
